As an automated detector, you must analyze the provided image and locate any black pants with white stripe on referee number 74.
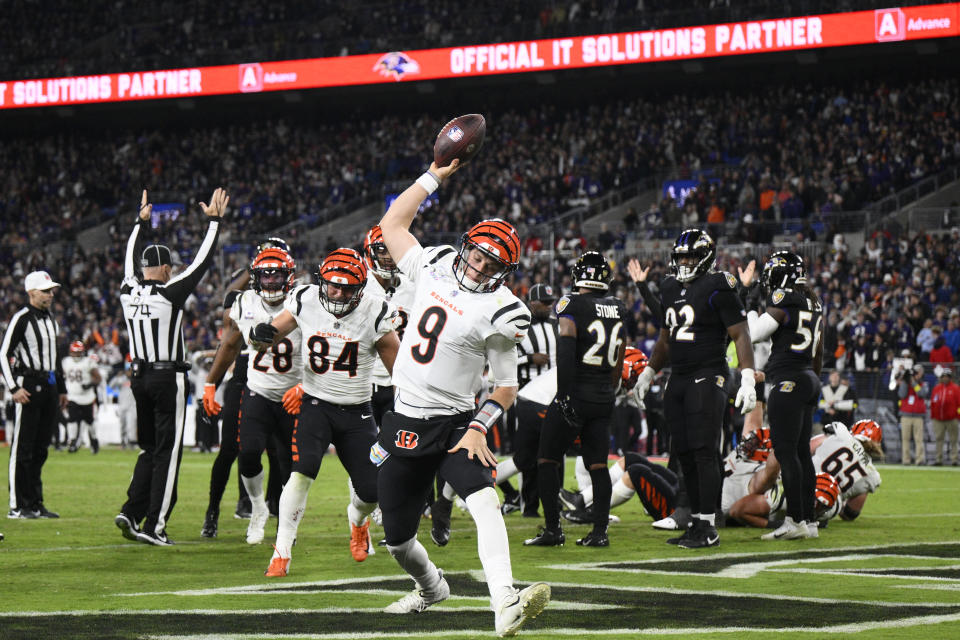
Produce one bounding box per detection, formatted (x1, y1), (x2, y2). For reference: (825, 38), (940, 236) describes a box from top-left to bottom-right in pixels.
(121, 370), (188, 534)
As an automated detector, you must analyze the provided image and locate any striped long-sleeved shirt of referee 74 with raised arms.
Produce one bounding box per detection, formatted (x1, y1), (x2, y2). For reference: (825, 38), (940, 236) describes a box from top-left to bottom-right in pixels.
(120, 218), (220, 362)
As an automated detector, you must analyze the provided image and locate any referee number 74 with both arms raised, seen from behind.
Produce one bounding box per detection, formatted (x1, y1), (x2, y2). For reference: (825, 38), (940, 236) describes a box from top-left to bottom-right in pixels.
(114, 189), (230, 546)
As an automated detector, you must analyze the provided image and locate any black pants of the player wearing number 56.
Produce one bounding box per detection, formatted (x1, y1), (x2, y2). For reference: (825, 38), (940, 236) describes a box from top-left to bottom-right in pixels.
(767, 369), (820, 522)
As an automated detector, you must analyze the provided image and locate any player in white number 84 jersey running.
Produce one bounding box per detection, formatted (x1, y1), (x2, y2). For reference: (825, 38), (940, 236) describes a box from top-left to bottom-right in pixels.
(253, 248), (400, 577)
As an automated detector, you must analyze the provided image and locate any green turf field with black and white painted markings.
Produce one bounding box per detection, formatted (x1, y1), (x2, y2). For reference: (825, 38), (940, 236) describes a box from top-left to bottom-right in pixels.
(0, 449), (960, 640)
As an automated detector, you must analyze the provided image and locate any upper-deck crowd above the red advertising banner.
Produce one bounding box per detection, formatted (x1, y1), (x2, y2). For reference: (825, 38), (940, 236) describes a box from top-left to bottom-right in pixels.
(0, 0), (923, 80)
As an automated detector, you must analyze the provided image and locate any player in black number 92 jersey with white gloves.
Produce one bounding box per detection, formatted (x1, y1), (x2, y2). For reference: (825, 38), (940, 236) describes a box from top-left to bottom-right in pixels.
(634, 229), (757, 549)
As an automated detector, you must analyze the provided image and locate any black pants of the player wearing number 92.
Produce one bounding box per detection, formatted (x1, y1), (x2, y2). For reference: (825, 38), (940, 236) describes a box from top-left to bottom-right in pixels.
(663, 368), (729, 514)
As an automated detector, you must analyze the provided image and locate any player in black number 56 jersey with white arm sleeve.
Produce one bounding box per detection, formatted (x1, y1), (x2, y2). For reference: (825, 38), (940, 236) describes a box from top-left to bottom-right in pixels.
(748, 251), (823, 540)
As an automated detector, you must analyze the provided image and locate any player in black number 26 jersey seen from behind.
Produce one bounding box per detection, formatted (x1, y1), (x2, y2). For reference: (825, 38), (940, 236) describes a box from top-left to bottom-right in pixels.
(524, 251), (627, 547)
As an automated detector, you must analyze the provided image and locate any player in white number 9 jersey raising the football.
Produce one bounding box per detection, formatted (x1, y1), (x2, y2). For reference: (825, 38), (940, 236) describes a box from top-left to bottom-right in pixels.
(371, 160), (550, 636)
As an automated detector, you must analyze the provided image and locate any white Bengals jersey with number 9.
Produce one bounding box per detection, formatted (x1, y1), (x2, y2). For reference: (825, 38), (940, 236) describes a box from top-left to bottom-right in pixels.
(393, 245), (530, 418)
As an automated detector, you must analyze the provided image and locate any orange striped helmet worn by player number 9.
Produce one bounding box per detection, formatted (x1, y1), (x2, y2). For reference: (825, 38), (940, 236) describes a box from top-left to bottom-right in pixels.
(453, 218), (520, 293)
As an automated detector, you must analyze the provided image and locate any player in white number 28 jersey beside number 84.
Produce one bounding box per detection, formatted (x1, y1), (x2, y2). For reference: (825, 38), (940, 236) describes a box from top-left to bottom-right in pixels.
(198, 247), (303, 544)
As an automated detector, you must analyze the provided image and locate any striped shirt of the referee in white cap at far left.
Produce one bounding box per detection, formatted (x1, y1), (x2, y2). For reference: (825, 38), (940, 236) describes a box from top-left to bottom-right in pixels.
(0, 304), (66, 393)
